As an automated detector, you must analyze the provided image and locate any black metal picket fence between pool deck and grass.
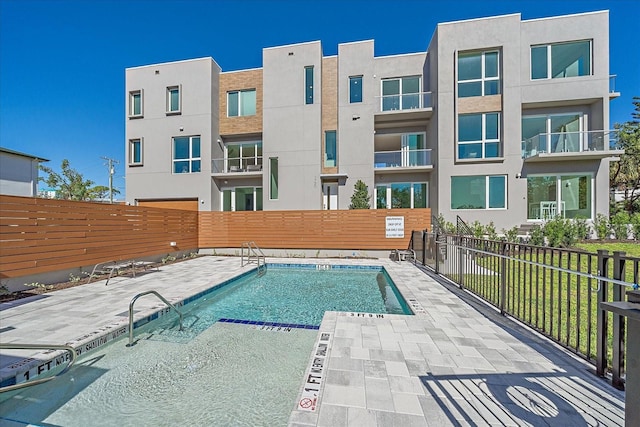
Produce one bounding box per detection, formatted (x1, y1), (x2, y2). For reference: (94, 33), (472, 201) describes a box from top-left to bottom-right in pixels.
(411, 231), (640, 389)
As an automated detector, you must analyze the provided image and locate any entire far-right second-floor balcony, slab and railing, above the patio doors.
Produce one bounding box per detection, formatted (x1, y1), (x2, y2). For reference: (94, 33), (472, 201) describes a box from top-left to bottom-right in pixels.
(522, 130), (624, 162)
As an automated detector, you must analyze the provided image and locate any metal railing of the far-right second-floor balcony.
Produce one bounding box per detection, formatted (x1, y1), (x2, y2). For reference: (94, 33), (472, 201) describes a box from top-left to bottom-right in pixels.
(522, 130), (617, 159)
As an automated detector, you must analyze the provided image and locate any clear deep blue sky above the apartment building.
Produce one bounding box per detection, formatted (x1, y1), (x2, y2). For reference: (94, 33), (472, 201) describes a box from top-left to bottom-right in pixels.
(0, 0), (640, 193)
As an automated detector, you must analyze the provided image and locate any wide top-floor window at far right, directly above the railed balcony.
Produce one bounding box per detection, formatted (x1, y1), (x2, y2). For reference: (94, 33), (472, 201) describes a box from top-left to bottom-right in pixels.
(531, 40), (591, 80)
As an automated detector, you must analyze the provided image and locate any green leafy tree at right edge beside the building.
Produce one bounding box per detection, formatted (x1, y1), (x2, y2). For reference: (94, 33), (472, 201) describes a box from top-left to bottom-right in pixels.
(609, 96), (640, 213)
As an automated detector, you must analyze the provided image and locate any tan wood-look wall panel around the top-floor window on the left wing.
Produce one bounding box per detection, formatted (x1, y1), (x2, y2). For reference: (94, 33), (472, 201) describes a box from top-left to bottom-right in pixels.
(219, 68), (263, 137)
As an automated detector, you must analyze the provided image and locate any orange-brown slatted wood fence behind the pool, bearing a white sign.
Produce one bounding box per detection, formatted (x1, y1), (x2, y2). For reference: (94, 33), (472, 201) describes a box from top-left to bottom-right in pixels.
(198, 209), (431, 250)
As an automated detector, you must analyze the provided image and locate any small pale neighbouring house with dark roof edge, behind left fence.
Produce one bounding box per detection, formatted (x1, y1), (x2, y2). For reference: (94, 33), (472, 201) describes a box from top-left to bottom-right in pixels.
(0, 147), (49, 197)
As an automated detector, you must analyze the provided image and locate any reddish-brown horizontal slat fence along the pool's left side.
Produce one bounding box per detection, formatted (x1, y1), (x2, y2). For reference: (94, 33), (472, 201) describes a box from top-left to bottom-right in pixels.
(0, 195), (198, 279)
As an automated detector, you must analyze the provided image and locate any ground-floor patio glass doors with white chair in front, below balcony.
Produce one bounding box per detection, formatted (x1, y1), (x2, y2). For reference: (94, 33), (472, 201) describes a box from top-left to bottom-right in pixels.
(527, 174), (593, 220)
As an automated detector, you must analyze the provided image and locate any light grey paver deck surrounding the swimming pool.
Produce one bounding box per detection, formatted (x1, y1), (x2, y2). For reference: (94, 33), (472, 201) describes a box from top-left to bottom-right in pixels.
(0, 256), (624, 426)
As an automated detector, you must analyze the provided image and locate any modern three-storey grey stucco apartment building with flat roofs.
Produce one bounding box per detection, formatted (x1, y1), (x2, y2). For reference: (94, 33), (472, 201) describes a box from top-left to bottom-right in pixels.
(125, 11), (620, 229)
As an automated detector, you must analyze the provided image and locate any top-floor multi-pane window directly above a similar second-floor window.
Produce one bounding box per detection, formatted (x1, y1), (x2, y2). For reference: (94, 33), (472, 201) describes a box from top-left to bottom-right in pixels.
(458, 51), (500, 98)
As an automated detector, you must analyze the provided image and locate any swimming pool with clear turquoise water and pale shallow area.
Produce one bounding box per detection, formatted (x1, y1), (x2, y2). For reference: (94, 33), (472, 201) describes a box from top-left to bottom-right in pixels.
(1, 265), (410, 427)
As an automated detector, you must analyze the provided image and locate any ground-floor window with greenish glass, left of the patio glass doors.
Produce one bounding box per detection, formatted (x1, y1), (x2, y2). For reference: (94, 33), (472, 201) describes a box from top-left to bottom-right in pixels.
(451, 175), (507, 210)
